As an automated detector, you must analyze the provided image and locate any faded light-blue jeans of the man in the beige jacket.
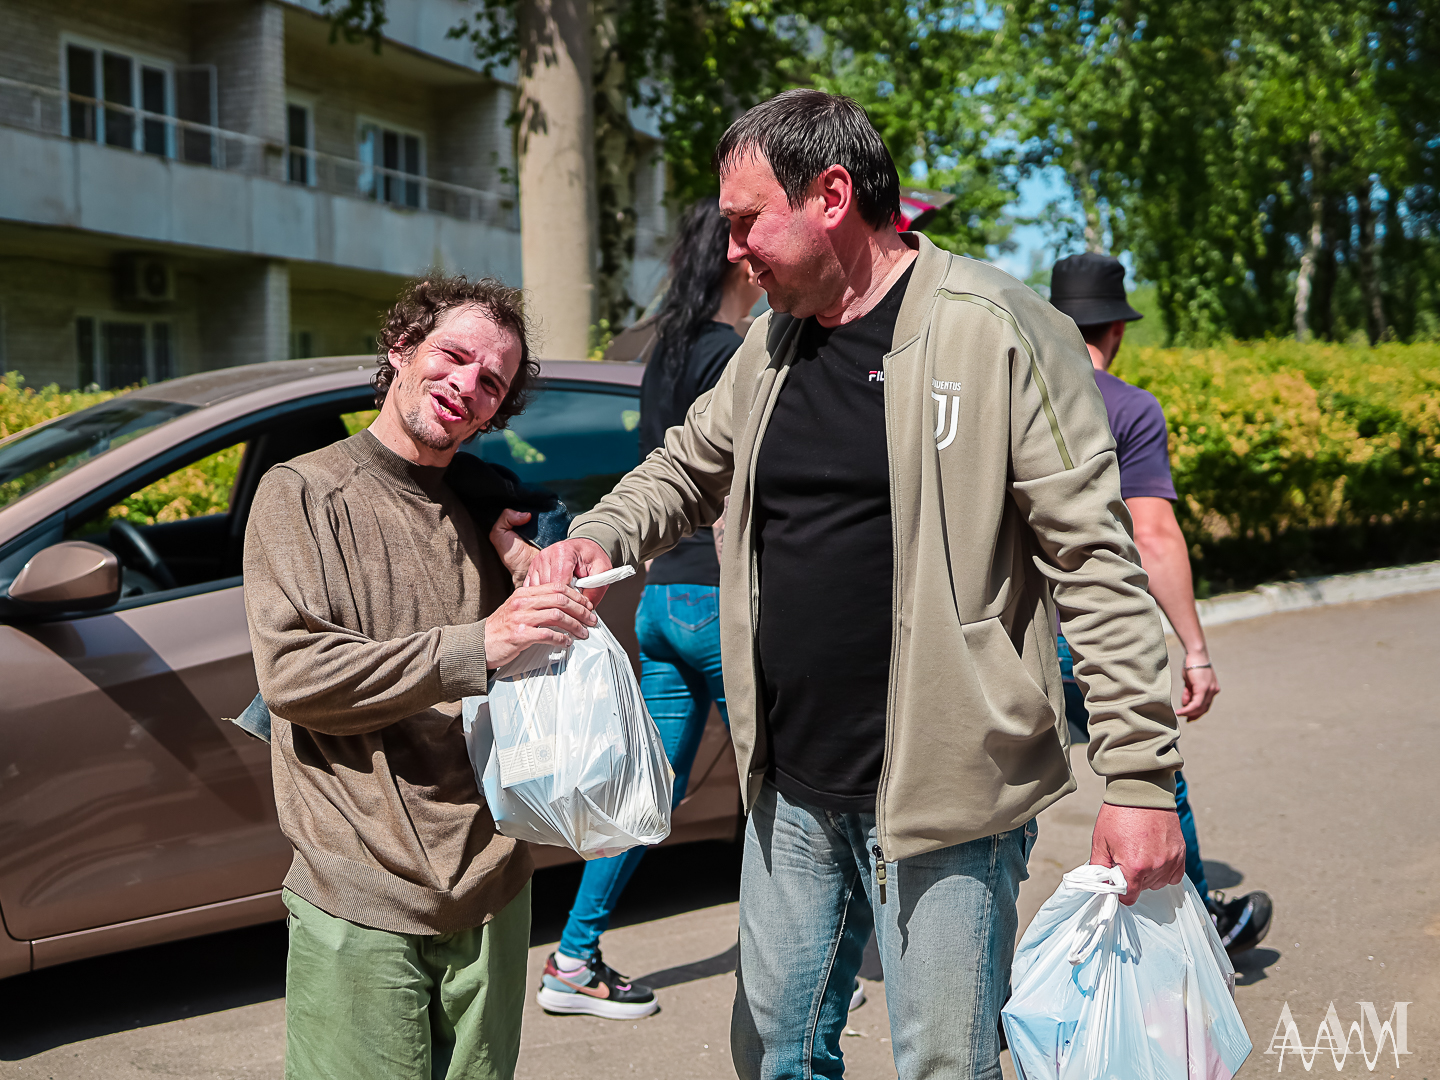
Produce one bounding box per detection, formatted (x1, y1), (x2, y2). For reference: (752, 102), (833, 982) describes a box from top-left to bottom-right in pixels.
(730, 782), (1035, 1080)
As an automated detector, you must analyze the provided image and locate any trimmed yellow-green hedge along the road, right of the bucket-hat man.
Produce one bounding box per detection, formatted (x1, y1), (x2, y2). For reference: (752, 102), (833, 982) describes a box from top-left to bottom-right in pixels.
(1113, 341), (1440, 583)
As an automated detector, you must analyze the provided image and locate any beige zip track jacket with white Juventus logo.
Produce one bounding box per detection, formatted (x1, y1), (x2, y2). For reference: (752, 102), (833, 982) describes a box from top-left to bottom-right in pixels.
(570, 235), (1182, 860)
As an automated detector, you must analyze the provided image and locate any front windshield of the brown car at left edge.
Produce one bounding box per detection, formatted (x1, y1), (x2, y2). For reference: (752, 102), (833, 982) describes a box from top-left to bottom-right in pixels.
(0, 397), (196, 507)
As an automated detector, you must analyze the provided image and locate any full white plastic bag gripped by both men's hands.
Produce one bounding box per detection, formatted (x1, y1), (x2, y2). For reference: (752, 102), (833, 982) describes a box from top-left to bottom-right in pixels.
(464, 566), (675, 860)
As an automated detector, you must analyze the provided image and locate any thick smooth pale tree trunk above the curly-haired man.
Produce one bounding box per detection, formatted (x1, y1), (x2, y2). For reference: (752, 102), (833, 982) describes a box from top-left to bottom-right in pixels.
(516, 0), (596, 360)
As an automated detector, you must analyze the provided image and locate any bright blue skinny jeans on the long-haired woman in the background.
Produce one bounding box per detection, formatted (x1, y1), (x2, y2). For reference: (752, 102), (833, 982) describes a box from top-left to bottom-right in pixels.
(560, 585), (730, 959)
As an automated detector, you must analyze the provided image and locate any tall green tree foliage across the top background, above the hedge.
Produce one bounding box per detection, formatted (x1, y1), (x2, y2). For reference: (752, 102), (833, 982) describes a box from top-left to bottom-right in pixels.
(321, 0), (1440, 344)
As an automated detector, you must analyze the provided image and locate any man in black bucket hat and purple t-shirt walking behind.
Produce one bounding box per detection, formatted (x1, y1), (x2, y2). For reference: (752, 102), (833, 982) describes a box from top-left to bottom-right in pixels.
(1050, 252), (1272, 955)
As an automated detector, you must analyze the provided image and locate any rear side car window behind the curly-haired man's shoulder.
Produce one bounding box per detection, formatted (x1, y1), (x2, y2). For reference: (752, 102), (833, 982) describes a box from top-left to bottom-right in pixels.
(465, 384), (639, 514)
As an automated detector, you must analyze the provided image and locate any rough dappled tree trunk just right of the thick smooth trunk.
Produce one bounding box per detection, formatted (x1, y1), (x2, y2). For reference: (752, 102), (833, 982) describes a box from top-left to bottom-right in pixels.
(593, 0), (639, 328)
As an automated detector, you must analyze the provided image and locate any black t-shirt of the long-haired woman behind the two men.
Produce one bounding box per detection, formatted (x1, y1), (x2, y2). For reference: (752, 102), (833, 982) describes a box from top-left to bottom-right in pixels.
(639, 321), (744, 585)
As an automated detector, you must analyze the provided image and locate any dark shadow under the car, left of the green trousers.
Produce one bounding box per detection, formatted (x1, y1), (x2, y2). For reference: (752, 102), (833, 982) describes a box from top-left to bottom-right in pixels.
(0, 922), (285, 1061)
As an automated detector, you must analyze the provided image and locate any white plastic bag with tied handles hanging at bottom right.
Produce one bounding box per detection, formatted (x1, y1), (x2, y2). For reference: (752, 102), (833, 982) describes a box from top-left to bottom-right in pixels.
(1001, 865), (1250, 1080)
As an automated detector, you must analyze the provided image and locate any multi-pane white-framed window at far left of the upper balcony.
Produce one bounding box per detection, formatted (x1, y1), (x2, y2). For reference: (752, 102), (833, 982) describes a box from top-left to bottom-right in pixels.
(65, 45), (174, 157)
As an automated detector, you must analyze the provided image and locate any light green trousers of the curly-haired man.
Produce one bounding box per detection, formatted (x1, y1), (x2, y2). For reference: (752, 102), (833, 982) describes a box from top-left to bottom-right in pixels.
(284, 883), (530, 1080)
